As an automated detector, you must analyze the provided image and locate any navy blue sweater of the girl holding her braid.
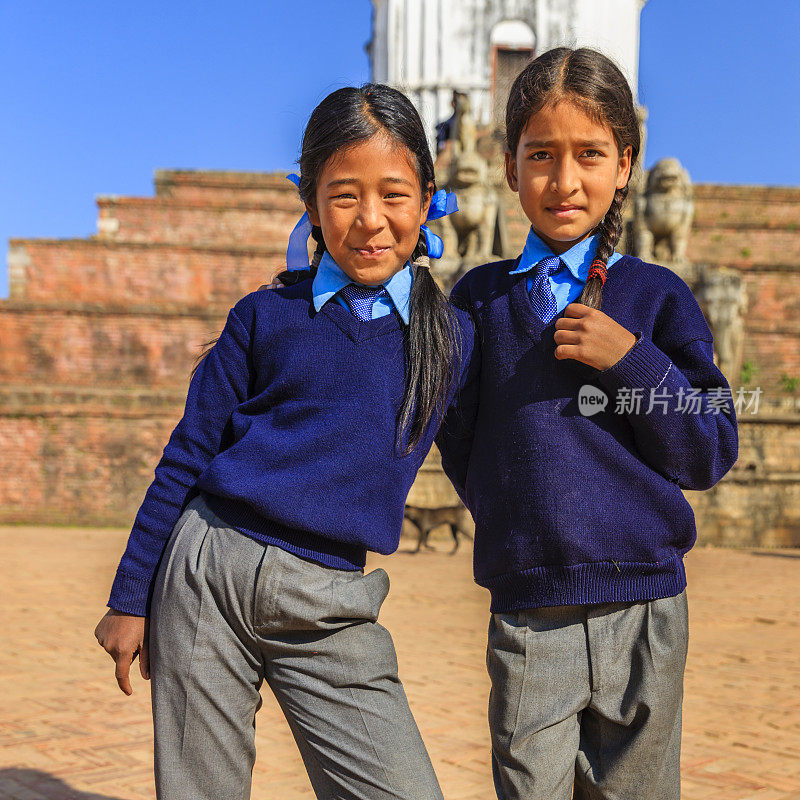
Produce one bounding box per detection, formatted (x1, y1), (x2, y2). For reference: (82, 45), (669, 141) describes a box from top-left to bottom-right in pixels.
(437, 256), (738, 612)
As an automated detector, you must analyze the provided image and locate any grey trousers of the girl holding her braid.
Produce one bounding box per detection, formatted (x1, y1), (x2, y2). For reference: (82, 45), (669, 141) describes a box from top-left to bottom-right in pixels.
(487, 590), (689, 800)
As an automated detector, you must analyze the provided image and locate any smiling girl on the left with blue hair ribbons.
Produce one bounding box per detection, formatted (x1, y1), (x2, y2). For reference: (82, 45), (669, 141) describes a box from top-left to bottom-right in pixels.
(95, 85), (474, 800)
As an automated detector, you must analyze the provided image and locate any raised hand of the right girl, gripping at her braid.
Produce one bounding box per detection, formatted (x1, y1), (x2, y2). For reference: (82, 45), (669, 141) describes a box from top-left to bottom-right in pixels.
(553, 303), (636, 370)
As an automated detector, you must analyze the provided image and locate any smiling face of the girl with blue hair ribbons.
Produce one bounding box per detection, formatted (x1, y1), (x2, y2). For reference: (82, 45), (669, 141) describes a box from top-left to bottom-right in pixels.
(306, 131), (433, 286)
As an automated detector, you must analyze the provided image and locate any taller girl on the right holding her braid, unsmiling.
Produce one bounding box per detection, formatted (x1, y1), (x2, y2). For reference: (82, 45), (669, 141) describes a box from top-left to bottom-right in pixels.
(437, 48), (738, 800)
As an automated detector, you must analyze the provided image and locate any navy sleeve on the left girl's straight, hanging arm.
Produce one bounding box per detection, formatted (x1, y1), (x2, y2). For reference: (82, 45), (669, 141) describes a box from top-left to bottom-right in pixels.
(108, 309), (250, 616)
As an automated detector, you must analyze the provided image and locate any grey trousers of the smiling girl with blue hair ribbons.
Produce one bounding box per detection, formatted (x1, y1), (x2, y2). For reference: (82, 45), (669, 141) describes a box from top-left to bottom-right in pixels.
(149, 497), (442, 800)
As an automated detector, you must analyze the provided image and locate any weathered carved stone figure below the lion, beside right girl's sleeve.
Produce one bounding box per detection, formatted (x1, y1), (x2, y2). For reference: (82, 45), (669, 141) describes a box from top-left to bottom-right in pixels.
(693, 268), (747, 383)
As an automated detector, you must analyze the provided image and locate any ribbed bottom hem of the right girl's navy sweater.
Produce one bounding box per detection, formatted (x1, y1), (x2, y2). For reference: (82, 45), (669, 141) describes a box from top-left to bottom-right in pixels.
(476, 554), (686, 614)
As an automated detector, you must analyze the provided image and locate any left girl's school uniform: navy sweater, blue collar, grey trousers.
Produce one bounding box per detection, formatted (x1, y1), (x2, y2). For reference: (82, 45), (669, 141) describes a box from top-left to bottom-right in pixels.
(109, 256), (473, 800)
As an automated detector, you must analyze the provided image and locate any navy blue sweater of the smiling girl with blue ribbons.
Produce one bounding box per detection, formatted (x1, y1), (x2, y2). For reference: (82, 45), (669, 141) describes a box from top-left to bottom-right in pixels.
(108, 280), (474, 615)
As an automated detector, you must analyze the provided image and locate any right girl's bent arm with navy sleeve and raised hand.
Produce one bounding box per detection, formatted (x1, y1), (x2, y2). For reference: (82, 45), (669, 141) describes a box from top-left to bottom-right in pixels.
(554, 292), (739, 489)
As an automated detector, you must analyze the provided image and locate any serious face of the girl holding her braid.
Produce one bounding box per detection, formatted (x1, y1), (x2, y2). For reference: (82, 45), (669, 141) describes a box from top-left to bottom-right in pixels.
(506, 101), (632, 254)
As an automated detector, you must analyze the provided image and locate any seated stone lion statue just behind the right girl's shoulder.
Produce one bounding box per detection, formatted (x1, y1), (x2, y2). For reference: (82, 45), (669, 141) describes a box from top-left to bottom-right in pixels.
(633, 158), (694, 264)
